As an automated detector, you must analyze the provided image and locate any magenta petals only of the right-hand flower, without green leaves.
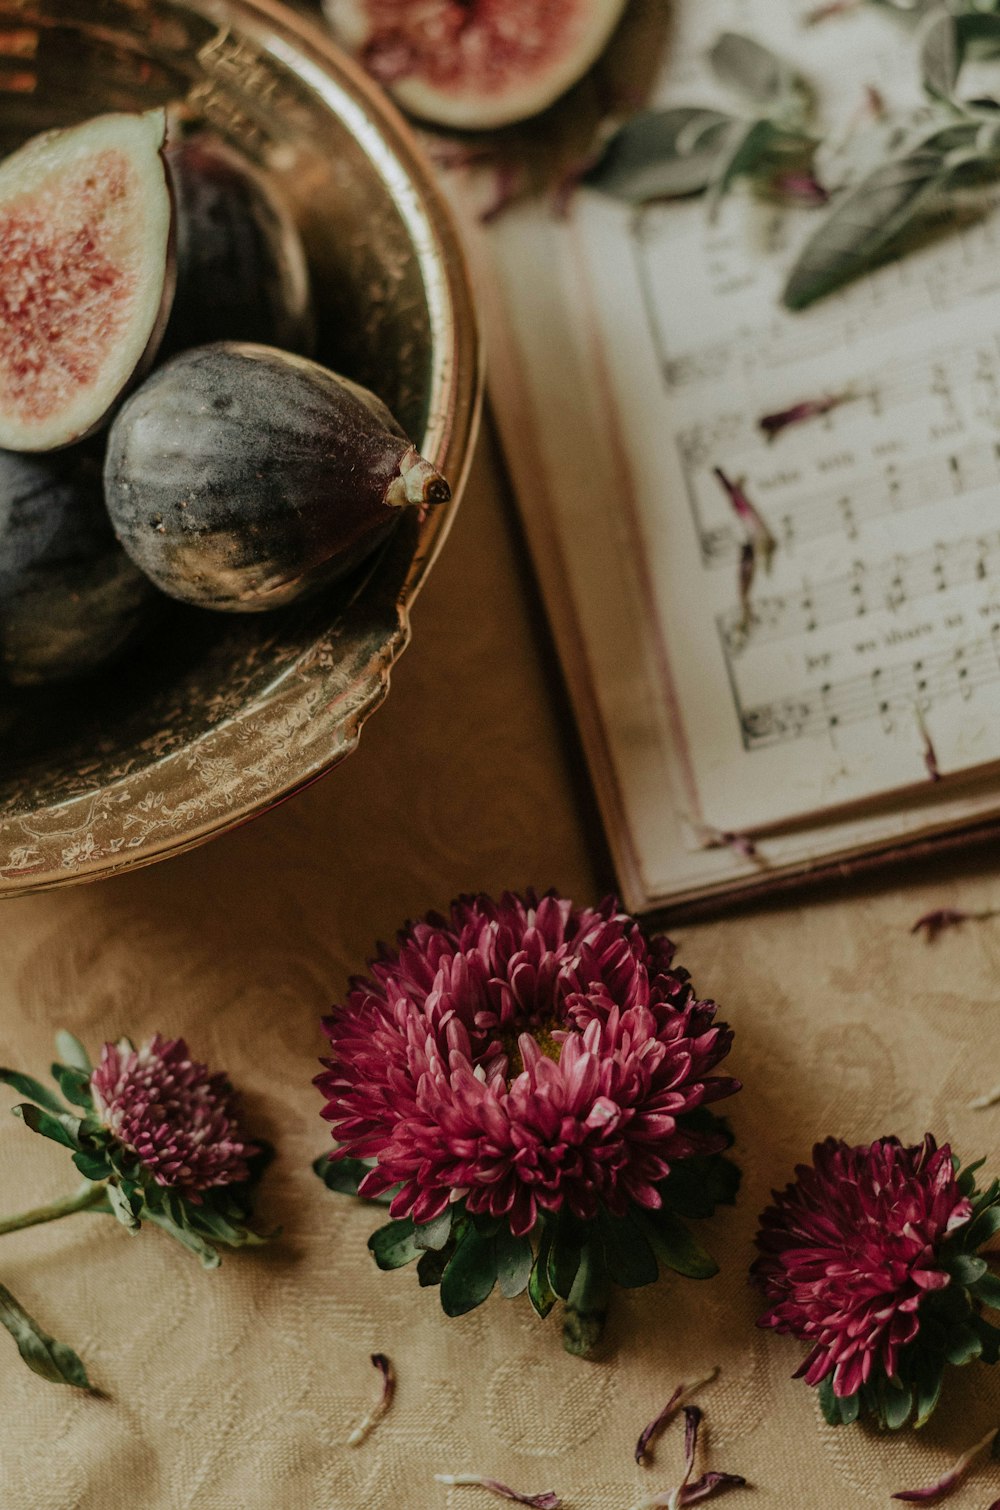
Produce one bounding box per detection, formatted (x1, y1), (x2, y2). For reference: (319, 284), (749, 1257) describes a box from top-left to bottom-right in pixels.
(751, 1133), (986, 1398)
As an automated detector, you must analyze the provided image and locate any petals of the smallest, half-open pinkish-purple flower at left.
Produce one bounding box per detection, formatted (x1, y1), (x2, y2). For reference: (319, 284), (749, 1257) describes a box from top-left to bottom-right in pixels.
(91, 1033), (258, 1202)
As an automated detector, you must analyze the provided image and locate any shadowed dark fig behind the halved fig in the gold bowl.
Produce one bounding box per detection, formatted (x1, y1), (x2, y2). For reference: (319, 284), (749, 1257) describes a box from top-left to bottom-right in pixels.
(160, 133), (316, 356)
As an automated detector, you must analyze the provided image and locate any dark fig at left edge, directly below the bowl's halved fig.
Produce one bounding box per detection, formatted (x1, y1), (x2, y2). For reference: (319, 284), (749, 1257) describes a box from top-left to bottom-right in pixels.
(0, 447), (162, 687)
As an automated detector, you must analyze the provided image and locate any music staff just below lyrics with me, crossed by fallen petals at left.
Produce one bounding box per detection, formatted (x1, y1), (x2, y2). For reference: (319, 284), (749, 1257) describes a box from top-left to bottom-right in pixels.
(697, 441), (1000, 568)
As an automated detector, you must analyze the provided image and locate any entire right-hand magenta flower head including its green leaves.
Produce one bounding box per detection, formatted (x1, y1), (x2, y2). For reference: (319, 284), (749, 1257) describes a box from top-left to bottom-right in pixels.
(751, 1134), (1000, 1427)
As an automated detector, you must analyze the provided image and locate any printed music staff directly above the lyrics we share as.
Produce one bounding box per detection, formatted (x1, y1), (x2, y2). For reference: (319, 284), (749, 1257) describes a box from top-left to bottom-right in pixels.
(716, 530), (1000, 655)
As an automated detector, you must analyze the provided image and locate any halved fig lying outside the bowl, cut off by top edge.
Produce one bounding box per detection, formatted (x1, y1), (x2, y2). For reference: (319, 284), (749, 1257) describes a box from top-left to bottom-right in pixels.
(323, 0), (627, 130)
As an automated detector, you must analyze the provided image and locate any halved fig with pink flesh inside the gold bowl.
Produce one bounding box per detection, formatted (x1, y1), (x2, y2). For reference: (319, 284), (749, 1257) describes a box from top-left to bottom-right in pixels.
(0, 110), (174, 451)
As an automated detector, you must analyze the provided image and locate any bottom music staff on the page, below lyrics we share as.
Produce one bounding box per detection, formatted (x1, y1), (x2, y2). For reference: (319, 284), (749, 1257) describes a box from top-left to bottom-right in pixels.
(737, 622), (1000, 750)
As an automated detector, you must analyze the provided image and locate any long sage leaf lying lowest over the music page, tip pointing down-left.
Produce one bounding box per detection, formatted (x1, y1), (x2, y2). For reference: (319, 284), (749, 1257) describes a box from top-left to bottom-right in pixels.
(782, 139), (952, 310)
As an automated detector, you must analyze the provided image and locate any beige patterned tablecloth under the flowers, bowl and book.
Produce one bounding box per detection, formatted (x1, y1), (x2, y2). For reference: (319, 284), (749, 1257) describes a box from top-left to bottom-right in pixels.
(0, 428), (1000, 1510)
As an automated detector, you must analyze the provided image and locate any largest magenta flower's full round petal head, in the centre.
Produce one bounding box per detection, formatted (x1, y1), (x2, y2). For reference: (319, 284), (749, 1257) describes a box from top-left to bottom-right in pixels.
(316, 892), (739, 1235)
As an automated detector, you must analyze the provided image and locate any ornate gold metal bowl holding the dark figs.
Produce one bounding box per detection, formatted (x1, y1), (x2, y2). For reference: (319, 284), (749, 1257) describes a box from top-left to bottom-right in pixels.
(0, 0), (480, 895)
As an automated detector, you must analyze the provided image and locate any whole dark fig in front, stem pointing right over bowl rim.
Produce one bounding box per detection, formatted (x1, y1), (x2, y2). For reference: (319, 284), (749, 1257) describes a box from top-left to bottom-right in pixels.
(104, 341), (450, 613)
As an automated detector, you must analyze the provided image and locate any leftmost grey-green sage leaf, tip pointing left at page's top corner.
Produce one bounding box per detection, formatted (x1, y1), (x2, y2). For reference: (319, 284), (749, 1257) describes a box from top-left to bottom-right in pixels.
(583, 106), (733, 204)
